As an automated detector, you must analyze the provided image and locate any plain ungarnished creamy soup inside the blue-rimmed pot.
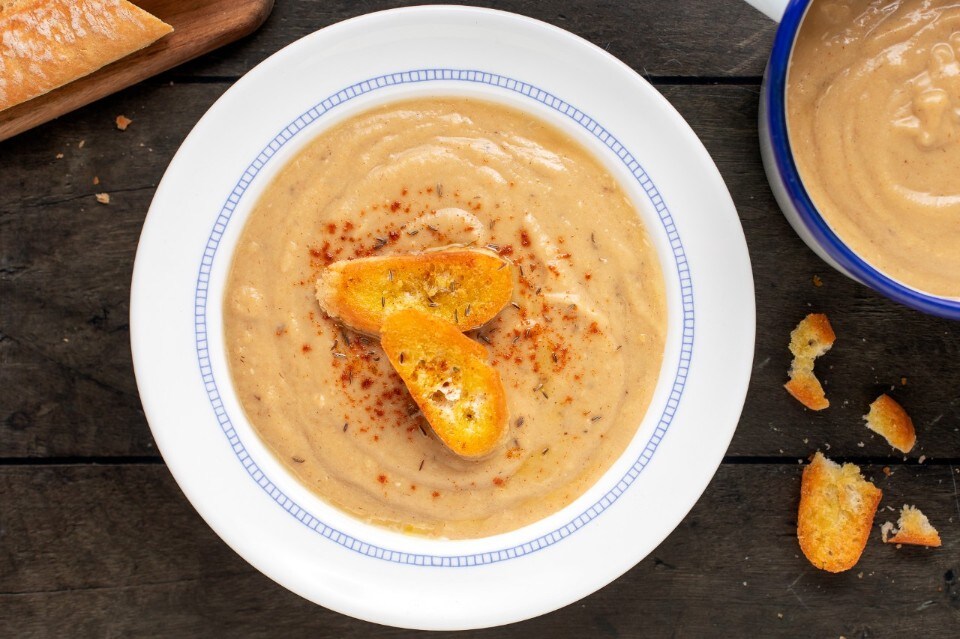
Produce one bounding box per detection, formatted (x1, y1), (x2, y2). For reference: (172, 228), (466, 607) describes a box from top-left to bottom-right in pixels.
(787, 0), (960, 298)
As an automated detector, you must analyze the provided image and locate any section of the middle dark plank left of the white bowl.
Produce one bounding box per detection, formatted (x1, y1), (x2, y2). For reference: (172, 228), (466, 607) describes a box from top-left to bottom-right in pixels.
(0, 83), (226, 457)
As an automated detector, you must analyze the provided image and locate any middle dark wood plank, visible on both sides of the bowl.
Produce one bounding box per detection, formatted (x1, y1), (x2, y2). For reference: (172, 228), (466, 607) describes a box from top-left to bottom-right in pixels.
(0, 80), (960, 461)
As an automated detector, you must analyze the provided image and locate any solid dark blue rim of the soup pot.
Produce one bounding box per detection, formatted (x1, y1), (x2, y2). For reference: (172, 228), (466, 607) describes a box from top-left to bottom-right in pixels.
(761, 0), (960, 320)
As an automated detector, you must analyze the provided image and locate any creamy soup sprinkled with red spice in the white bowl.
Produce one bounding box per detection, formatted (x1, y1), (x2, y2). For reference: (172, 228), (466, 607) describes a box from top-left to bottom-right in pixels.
(224, 98), (666, 538)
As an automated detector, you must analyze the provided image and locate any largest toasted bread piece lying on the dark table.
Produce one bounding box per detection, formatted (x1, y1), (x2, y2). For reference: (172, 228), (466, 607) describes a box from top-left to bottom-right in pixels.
(797, 452), (883, 572)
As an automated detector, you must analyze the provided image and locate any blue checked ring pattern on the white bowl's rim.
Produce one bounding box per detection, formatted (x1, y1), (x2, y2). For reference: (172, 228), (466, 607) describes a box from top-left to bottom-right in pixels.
(195, 69), (694, 567)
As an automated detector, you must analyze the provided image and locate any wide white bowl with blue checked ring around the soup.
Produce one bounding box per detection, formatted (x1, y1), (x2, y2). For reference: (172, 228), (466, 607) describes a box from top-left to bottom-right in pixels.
(130, 7), (755, 629)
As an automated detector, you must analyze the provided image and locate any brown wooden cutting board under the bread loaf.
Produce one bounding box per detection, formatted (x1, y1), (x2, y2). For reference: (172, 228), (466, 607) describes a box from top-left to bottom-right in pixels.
(0, 0), (274, 141)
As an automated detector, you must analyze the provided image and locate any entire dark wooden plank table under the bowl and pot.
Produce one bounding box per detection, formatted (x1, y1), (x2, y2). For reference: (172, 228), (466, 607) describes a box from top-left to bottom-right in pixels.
(0, 0), (960, 639)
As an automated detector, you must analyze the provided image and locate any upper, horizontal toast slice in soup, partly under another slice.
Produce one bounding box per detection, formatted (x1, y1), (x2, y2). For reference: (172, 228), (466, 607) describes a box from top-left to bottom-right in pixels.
(317, 249), (513, 334)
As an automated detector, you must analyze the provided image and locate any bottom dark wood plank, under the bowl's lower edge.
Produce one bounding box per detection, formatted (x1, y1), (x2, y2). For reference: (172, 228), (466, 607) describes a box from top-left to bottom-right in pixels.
(0, 464), (960, 639)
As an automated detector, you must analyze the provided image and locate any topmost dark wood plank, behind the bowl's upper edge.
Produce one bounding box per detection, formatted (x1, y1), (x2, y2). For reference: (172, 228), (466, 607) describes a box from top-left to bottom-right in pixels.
(165, 0), (776, 80)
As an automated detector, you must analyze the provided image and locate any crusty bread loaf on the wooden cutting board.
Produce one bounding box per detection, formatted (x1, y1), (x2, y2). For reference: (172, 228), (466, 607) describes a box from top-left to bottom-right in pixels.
(0, 0), (173, 111)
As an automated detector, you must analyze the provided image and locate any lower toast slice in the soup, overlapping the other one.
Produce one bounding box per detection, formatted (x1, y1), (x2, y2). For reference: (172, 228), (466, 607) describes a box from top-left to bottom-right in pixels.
(381, 309), (507, 458)
